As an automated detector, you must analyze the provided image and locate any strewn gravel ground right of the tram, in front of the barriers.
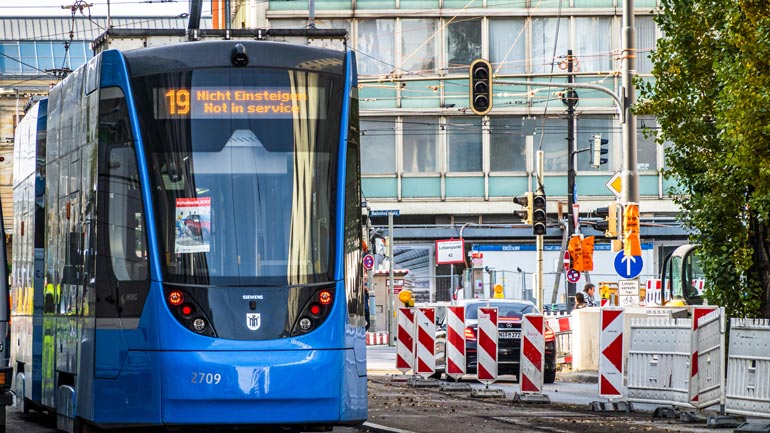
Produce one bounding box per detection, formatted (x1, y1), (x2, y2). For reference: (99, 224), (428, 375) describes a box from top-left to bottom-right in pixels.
(361, 375), (731, 433)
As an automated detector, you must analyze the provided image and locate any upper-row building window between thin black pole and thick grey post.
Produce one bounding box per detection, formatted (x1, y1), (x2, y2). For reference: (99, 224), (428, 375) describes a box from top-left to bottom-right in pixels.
(568, 17), (612, 72)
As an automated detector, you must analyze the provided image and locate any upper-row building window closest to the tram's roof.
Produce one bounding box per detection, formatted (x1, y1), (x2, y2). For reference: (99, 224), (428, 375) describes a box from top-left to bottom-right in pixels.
(356, 20), (396, 75)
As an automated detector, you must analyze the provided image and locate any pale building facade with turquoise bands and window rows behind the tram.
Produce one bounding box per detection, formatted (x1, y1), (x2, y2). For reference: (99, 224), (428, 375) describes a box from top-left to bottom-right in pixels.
(242, 0), (686, 302)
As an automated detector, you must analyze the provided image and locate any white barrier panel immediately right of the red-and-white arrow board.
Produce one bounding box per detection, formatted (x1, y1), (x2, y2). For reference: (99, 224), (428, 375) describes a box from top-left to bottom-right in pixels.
(627, 318), (692, 406)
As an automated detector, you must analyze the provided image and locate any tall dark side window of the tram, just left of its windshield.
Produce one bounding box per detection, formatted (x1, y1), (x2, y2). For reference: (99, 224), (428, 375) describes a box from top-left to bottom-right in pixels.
(96, 88), (149, 317)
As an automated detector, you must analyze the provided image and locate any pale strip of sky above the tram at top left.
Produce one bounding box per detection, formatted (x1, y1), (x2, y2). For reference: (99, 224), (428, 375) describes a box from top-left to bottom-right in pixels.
(0, 0), (198, 18)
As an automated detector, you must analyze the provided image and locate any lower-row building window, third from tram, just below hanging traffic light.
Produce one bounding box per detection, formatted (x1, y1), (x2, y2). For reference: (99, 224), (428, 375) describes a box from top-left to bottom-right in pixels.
(446, 117), (483, 173)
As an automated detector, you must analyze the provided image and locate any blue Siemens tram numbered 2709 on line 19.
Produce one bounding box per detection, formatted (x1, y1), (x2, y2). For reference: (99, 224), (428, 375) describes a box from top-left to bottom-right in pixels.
(11, 41), (368, 431)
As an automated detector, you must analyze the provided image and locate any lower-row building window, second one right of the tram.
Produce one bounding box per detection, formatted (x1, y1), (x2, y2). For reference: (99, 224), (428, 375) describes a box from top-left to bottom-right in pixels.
(402, 117), (438, 173)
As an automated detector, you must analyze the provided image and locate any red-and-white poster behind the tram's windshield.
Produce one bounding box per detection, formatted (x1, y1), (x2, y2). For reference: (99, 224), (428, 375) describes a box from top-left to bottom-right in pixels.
(174, 197), (211, 253)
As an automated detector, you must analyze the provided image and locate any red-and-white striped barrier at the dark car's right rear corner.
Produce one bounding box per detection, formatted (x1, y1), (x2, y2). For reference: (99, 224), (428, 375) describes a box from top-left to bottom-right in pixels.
(519, 314), (545, 394)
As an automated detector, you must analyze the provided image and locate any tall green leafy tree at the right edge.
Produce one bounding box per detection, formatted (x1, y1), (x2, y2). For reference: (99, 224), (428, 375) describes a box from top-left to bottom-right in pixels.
(637, 0), (770, 318)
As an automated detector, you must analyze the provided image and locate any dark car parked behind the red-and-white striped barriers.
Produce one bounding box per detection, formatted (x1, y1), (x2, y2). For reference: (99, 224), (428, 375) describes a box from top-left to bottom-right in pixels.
(433, 299), (556, 383)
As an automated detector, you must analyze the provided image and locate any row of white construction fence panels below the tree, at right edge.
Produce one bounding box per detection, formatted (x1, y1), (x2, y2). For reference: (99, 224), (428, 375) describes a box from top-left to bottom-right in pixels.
(626, 307), (770, 418)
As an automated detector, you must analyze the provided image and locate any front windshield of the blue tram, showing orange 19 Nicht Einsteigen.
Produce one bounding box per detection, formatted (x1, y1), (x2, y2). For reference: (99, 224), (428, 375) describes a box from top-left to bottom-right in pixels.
(132, 68), (343, 286)
